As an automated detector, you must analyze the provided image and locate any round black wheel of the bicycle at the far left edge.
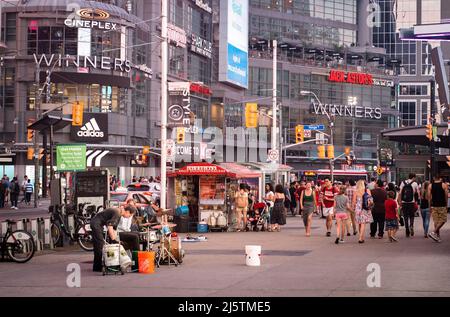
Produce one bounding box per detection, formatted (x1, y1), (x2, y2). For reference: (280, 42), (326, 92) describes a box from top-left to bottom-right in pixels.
(6, 230), (35, 263)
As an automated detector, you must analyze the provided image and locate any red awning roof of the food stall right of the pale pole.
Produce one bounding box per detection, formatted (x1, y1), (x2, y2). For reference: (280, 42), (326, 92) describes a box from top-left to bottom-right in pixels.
(167, 163), (261, 178)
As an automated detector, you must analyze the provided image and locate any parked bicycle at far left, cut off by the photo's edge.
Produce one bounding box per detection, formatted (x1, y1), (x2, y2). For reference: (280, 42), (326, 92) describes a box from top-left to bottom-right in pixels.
(0, 220), (35, 263)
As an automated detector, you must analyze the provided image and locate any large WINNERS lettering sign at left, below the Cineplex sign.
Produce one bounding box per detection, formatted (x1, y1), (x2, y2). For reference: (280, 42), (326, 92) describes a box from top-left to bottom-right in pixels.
(33, 54), (132, 73)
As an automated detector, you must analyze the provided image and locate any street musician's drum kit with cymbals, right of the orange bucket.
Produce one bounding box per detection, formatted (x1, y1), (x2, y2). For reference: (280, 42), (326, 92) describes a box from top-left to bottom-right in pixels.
(141, 209), (184, 267)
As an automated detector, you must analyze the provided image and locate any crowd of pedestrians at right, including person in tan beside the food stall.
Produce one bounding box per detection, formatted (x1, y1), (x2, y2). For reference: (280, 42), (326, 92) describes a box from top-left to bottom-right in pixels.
(235, 174), (449, 244)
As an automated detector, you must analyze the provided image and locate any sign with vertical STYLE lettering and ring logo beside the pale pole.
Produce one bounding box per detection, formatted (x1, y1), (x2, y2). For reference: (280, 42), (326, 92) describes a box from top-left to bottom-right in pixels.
(167, 81), (192, 127)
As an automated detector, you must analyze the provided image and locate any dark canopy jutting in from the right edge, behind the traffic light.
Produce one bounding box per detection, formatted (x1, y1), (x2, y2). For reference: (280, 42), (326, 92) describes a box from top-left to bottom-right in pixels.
(381, 124), (450, 148)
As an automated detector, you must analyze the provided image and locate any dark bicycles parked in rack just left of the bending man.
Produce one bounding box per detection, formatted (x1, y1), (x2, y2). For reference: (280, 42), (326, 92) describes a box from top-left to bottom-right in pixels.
(49, 203), (94, 251)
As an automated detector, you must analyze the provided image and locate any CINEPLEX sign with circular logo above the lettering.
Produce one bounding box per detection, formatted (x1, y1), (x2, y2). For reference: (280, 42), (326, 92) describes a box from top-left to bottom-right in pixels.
(64, 8), (117, 30)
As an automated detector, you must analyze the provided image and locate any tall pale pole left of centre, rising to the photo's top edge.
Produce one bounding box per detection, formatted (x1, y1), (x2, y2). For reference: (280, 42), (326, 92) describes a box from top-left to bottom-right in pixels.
(161, 0), (168, 208)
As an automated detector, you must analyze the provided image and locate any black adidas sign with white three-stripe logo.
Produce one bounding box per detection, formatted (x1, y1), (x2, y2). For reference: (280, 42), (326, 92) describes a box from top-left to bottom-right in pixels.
(70, 113), (108, 143)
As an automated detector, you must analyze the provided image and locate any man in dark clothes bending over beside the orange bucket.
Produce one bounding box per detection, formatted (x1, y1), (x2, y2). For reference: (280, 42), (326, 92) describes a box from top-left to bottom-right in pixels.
(91, 205), (136, 272)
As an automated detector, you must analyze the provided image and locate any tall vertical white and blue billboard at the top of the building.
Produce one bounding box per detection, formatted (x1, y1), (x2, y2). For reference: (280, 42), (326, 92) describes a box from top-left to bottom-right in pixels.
(219, 0), (248, 88)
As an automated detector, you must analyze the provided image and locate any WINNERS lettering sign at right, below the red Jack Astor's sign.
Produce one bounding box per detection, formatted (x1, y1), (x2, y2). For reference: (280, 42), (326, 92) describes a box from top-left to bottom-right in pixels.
(312, 103), (382, 120)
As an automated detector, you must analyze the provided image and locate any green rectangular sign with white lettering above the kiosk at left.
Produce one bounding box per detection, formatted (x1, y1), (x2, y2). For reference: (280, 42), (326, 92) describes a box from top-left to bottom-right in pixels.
(56, 144), (86, 172)
